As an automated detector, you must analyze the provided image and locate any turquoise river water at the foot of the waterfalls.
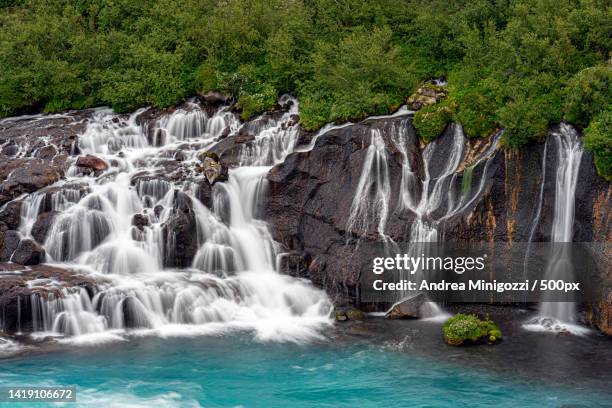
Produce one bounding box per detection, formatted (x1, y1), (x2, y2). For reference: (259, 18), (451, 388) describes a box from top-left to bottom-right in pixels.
(0, 308), (612, 407)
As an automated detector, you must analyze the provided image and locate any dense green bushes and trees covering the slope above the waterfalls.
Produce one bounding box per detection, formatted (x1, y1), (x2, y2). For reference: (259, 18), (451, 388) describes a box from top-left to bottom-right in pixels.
(0, 0), (612, 178)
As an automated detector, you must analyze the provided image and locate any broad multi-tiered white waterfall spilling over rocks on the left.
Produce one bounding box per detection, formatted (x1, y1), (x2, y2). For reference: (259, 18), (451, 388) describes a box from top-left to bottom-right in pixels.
(13, 98), (331, 342)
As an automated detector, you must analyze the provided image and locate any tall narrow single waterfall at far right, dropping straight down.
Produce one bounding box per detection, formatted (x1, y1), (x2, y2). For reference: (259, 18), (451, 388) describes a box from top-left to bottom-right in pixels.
(526, 123), (584, 334)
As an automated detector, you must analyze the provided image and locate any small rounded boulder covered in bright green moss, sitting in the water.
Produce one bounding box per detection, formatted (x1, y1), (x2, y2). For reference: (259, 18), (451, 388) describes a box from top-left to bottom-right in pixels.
(443, 313), (502, 346)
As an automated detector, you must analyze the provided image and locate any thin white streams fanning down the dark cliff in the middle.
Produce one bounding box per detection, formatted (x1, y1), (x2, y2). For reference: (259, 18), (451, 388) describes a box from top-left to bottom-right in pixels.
(347, 120), (501, 317)
